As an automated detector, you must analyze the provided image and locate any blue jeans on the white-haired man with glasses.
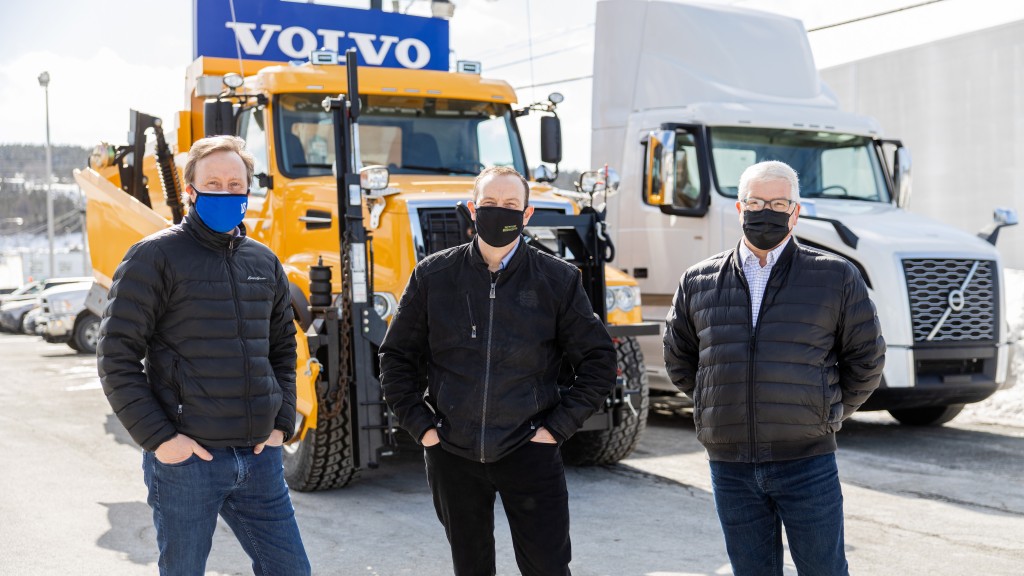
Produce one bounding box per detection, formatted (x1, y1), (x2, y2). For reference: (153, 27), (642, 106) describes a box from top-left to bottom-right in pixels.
(711, 454), (849, 576)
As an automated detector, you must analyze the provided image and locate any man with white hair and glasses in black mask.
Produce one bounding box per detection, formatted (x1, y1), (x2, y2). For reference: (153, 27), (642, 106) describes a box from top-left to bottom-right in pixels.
(665, 162), (885, 576)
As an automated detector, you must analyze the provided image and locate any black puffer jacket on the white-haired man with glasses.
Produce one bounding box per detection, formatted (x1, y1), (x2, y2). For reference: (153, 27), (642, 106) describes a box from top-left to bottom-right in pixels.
(665, 239), (886, 462)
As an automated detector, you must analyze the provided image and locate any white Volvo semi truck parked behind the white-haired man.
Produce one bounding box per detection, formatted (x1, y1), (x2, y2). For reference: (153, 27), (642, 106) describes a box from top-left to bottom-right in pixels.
(592, 0), (1017, 424)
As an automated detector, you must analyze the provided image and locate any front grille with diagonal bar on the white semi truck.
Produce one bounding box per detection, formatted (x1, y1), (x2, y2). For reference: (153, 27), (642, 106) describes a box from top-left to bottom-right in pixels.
(903, 258), (998, 342)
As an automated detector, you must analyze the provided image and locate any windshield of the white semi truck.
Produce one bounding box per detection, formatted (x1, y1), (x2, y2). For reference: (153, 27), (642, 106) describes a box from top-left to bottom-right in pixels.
(711, 127), (889, 202)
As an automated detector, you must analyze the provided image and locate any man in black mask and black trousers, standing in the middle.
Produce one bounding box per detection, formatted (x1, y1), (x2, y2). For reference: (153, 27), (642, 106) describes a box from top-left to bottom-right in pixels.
(380, 163), (615, 576)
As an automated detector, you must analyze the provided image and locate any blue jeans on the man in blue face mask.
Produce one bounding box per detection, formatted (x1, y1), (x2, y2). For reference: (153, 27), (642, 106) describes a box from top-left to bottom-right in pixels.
(142, 446), (310, 576)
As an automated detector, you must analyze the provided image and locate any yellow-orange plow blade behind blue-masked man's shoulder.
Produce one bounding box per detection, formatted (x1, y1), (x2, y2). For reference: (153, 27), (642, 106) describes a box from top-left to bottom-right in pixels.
(75, 168), (171, 289)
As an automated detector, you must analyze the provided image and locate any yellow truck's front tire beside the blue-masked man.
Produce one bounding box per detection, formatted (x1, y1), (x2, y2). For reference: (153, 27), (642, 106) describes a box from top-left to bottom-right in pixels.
(285, 406), (358, 485)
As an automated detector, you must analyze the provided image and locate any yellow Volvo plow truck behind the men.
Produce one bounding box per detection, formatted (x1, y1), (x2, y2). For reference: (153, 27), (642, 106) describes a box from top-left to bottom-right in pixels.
(76, 50), (657, 490)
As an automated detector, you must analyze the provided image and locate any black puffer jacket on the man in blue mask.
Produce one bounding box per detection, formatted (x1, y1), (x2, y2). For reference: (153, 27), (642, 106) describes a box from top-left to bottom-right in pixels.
(96, 216), (296, 451)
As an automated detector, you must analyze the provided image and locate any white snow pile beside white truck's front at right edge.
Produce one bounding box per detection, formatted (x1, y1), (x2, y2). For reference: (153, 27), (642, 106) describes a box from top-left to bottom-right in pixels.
(956, 269), (1024, 427)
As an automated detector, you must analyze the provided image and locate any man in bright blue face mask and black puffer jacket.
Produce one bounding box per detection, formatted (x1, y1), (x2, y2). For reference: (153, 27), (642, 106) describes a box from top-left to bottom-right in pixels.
(96, 136), (310, 575)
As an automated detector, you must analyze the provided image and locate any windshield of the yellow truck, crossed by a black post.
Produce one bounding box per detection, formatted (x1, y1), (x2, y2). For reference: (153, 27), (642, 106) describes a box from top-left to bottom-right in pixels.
(274, 93), (526, 178)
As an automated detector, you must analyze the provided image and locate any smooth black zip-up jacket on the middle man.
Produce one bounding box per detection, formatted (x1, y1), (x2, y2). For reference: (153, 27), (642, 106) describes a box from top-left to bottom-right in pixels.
(380, 240), (615, 462)
